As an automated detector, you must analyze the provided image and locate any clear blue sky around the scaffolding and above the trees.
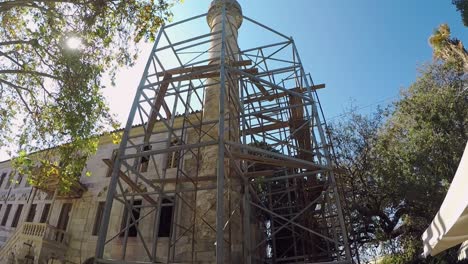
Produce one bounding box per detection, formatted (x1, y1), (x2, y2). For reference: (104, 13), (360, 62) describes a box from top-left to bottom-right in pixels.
(105, 0), (468, 123)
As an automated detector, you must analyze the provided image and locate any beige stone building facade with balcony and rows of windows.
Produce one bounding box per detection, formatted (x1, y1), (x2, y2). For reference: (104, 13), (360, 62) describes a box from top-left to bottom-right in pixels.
(0, 127), (183, 264)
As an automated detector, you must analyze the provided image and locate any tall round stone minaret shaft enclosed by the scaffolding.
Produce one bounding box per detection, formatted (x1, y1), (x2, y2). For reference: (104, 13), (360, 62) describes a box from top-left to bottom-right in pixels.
(195, 0), (242, 263)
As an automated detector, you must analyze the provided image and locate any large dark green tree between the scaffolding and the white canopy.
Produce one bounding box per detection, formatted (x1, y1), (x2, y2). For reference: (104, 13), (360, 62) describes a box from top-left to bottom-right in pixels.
(333, 54), (468, 263)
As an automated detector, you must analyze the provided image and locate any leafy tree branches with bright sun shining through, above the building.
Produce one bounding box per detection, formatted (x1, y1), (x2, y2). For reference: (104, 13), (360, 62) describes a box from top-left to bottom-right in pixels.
(0, 0), (179, 190)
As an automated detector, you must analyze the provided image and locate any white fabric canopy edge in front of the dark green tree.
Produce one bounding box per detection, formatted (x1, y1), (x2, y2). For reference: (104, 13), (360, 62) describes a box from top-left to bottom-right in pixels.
(422, 144), (468, 257)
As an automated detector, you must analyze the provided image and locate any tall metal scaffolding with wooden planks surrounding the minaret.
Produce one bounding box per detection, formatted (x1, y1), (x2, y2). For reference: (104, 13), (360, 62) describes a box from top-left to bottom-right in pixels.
(96, 1), (351, 263)
